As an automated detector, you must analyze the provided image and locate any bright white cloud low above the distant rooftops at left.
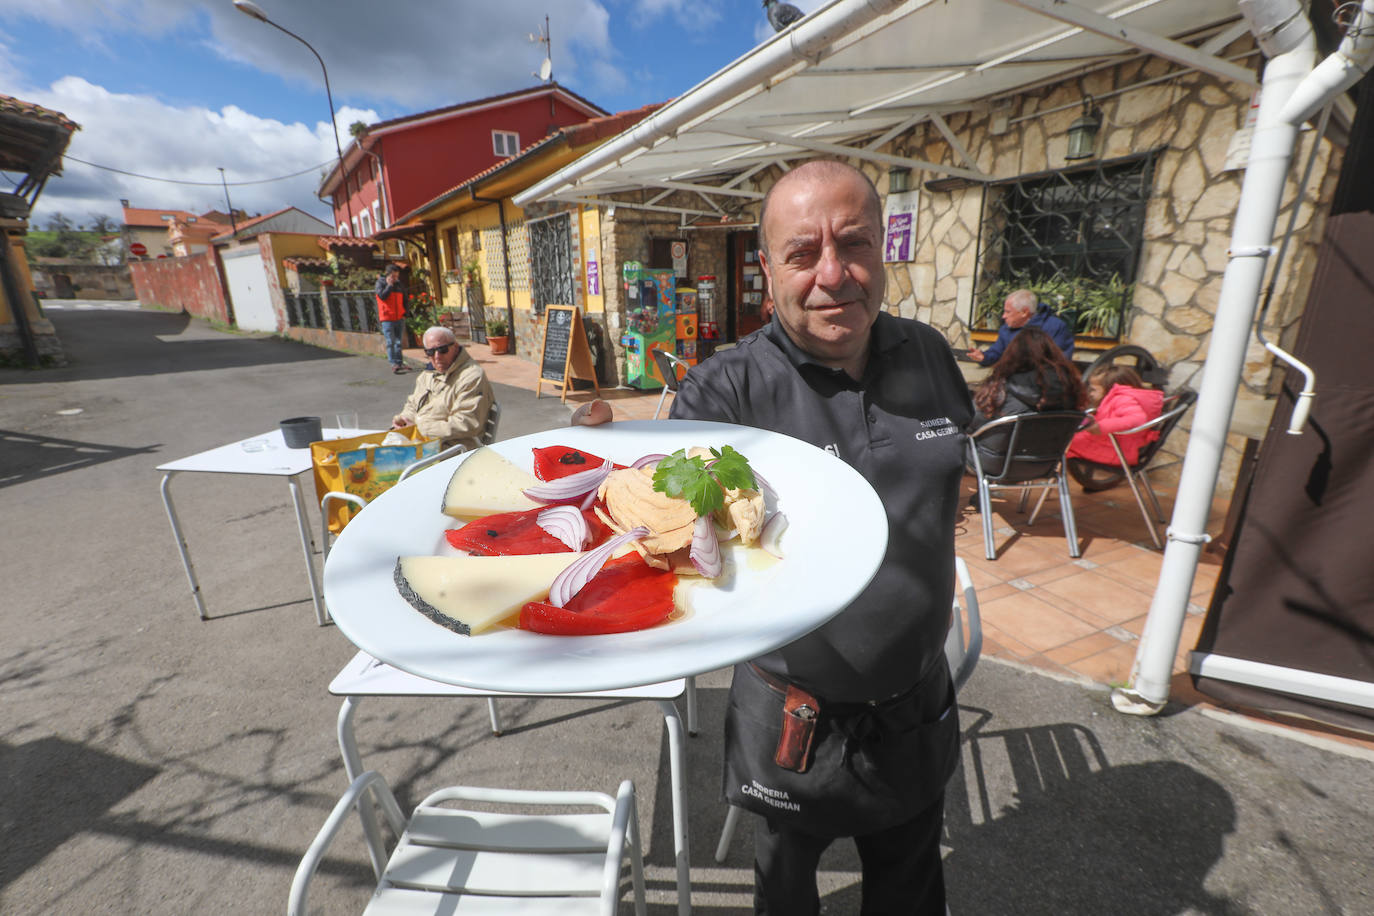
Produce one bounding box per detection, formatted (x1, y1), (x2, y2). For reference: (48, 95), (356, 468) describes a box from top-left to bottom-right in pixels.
(21, 77), (376, 225)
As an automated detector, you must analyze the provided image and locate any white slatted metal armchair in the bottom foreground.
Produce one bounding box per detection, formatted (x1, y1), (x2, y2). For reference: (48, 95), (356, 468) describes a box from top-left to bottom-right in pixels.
(287, 772), (644, 916)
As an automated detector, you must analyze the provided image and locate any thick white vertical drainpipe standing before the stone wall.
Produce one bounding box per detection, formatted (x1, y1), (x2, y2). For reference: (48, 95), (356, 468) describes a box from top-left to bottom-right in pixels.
(1112, 0), (1374, 715)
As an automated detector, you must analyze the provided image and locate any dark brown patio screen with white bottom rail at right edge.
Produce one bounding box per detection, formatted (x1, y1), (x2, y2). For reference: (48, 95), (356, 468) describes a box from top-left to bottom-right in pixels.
(1194, 211), (1374, 732)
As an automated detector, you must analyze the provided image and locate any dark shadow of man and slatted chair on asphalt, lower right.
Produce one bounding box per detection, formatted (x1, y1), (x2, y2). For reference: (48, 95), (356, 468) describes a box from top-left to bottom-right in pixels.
(945, 707), (1249, 916)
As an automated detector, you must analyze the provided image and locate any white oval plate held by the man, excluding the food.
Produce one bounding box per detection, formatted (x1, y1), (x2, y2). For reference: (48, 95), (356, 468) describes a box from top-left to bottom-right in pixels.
(324, 420), (888, 694)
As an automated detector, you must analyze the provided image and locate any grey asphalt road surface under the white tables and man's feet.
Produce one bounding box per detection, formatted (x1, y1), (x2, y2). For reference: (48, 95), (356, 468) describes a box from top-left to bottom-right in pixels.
(0, 304), (1374, 916)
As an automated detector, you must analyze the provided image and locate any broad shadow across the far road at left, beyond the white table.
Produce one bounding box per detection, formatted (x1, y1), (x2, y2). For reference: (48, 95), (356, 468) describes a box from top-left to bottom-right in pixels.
(0, 310), (349, 385)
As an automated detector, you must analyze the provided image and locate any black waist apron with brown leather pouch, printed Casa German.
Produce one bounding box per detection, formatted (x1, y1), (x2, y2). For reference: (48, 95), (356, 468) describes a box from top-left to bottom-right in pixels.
(724, 658), (959, 836)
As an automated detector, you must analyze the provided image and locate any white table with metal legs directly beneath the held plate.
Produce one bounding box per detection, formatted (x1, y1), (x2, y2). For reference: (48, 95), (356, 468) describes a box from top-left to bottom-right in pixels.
(330, 652), (697, 915)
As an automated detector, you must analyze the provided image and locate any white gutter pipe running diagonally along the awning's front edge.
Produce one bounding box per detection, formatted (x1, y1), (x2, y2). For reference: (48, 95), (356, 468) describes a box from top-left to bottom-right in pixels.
(514, 0), (907, 207)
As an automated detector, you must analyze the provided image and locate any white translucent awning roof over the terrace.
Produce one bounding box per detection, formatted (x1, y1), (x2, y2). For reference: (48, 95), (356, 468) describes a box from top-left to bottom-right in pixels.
(515, 0), (1257, 216)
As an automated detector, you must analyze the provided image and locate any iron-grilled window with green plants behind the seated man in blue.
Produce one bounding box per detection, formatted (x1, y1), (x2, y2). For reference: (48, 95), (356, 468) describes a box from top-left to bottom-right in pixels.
(969, 152), (1154, 339)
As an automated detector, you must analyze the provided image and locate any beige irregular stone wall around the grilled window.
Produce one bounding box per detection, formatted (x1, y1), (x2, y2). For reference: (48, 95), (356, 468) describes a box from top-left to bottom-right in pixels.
(884, 37), (1341, 492)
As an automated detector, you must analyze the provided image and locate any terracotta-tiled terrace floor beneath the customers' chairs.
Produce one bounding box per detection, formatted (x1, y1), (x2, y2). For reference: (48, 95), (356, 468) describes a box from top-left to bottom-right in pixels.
(417, 343), (1374, 748)
